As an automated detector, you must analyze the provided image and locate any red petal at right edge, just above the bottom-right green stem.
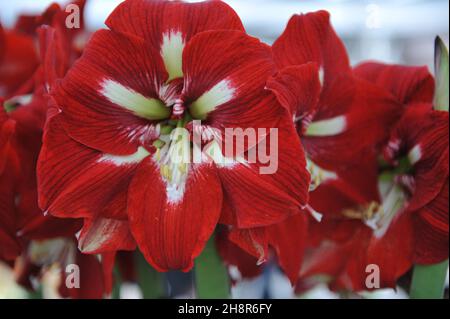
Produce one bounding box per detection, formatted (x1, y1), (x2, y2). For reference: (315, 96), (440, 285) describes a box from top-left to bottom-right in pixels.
(414, 180), (449, 265)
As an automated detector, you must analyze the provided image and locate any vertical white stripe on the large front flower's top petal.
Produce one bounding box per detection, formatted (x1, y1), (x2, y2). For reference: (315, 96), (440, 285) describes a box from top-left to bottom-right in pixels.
(161, 30), (185, 81)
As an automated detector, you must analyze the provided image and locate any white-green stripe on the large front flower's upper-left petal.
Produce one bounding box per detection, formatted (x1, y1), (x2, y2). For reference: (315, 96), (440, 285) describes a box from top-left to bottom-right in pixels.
(100, 79), (170, 120)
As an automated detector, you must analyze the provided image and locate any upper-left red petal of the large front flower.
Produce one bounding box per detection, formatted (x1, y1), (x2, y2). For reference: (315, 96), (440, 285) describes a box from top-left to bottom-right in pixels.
(54, 30), (167, 155)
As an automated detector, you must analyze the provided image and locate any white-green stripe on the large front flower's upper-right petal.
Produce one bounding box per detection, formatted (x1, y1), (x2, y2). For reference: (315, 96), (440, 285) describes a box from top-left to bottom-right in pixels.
(189, 79), (236, 120)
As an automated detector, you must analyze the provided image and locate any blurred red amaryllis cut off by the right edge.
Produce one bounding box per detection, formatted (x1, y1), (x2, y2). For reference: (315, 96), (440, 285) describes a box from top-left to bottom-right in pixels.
(303, 104), (449, 290)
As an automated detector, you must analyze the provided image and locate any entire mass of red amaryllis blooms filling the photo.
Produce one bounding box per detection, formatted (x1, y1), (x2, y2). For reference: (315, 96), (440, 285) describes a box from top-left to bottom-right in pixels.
(0, 0), (449, 297)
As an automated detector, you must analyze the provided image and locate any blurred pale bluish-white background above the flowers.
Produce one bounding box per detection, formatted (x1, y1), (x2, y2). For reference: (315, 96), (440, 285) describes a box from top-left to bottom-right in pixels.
(0, 0), (449, 67)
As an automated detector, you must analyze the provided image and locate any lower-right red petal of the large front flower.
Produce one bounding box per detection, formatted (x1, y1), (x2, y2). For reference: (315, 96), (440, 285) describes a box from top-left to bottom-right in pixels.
(219, 116), (310, 228)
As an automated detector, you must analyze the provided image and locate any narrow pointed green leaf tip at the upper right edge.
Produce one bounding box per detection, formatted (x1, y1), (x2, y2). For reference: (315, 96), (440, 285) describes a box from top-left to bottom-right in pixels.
(434, 37), (449, 112)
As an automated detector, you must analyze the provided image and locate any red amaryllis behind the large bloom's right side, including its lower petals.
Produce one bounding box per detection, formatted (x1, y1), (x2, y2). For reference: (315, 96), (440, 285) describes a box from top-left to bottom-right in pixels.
(215, 11), (401, 283)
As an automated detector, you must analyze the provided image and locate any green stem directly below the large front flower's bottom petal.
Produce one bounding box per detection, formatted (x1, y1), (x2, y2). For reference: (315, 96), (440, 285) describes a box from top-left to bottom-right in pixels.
(195, 236), (230, 299)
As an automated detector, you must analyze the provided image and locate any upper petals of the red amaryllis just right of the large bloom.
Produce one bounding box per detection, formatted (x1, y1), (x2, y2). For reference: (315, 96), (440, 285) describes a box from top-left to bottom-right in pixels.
(268, 11), (400, 172)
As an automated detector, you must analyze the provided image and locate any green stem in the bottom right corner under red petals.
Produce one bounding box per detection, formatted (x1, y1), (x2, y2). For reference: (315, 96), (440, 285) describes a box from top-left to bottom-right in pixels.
(410, 259), (448, 299)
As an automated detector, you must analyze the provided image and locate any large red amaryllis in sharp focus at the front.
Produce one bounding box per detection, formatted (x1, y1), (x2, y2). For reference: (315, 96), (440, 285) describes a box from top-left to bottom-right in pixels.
(38, 0), (309, 271)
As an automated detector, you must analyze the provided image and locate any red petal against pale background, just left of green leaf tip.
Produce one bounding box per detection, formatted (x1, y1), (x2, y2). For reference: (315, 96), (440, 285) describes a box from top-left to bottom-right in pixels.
(354, 62), (434, 104)
